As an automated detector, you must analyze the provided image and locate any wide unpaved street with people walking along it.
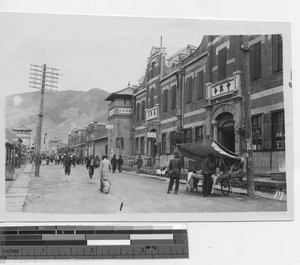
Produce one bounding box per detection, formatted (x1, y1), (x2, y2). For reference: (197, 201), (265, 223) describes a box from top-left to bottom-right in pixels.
(19, 164), (287, 214)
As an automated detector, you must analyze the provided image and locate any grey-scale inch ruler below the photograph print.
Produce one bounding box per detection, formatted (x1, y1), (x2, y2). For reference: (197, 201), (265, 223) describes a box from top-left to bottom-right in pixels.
(0, 224), (189, 259)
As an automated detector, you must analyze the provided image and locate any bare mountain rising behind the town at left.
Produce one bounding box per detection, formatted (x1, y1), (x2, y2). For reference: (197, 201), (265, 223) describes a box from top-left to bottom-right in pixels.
(5, 88), (110, 142)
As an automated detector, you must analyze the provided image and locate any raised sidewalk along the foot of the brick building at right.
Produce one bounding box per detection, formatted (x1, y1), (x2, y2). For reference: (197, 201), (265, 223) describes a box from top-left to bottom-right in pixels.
(123, 169), (287, 201)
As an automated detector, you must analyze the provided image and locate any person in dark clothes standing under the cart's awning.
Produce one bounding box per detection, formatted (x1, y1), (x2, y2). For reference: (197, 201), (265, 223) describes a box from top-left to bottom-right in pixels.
(202, 154), (215, 197)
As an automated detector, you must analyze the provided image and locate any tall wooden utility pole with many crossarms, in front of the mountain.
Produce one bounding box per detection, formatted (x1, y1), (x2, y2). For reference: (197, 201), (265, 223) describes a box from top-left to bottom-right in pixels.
(29, 64), (59, 177)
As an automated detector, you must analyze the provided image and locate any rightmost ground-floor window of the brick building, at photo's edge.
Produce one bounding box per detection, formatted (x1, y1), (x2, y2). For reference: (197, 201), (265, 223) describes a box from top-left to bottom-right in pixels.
(272, 111), (285, 150)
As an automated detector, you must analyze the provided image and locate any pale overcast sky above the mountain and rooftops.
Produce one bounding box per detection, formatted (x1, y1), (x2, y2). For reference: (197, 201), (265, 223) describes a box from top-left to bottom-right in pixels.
(0, 13), (209, 95)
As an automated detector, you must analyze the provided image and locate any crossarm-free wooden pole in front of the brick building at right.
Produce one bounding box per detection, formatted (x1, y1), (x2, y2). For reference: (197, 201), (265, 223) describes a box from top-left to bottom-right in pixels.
(241, 35), (255, 197)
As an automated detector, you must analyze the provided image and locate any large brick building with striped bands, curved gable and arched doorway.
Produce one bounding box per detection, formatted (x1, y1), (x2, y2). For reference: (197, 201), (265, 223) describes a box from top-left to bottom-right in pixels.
(128, 35), (285, 172)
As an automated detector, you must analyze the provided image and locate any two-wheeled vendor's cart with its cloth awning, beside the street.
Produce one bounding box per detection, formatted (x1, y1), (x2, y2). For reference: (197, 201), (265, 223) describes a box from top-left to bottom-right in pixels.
(177, 139), (243, 196)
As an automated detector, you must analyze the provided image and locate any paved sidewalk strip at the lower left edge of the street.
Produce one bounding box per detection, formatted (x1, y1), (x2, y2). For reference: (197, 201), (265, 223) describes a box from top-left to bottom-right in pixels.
(5, 164), (33, 212)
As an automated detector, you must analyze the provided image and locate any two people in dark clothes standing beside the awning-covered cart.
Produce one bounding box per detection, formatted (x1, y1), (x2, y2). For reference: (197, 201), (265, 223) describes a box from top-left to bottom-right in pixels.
(167, 152), (216, 197)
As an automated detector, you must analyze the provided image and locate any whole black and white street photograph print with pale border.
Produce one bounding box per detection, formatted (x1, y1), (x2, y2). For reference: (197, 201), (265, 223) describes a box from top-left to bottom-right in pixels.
(0, 13), (293, 221)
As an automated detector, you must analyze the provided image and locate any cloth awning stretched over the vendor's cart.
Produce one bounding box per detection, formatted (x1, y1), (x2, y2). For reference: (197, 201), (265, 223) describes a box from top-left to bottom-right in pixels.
(177, 139), (242, 160)
